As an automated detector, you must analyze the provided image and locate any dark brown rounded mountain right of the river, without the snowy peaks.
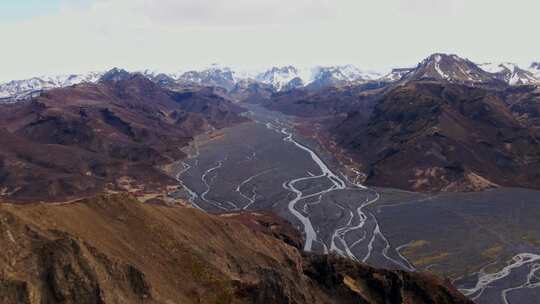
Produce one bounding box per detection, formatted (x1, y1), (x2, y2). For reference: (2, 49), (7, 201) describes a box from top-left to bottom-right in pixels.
(333, 81), (540, 191)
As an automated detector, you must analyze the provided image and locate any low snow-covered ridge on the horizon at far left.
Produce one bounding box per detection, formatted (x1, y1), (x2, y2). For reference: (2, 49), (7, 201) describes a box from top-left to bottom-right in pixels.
(0, 72), (103, 101)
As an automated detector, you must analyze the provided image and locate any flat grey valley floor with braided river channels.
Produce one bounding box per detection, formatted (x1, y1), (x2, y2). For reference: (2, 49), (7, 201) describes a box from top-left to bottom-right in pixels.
(174, 107), (540, 304)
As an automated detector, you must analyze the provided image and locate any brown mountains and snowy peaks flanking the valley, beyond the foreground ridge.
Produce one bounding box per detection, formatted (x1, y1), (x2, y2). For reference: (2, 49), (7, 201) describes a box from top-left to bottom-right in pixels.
(0, 53), (540, 199)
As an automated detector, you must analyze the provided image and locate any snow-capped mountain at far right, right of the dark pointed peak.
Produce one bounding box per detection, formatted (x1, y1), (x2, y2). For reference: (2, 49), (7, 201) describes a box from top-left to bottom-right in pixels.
(479, 62), (539, 85)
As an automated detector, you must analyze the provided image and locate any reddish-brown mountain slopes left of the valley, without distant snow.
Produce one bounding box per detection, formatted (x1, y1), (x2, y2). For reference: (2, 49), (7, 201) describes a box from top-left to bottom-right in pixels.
(0, 74), (245, 201)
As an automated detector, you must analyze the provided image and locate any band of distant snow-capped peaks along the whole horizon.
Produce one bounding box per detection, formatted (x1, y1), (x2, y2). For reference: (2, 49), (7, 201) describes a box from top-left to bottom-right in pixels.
(0, 54), (540, 102)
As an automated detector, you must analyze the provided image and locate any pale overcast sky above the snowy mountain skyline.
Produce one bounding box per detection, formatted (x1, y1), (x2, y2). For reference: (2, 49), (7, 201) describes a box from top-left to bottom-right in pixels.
(0, 0), (540, 81)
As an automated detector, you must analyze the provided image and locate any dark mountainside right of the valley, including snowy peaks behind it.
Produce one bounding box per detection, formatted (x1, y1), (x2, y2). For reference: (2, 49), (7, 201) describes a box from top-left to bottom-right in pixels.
(248, 54), (540, 192)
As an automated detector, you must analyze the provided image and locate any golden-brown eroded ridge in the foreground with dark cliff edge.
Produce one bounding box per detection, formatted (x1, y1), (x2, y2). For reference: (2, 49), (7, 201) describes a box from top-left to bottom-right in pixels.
(0, 195), (472, 304)
